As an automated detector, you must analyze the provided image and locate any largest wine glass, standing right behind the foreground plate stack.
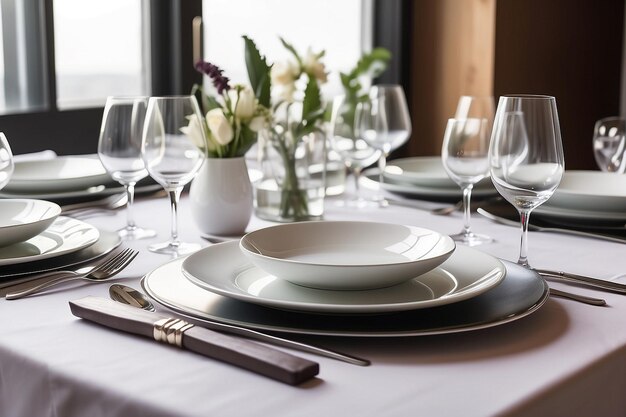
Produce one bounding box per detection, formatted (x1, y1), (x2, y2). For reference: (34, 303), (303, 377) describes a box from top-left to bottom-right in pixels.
(489, 95), (565, 267)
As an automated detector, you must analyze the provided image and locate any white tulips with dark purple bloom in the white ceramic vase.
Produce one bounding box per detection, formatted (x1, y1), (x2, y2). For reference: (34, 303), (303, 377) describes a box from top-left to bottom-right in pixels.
(186, 37), (270, 158)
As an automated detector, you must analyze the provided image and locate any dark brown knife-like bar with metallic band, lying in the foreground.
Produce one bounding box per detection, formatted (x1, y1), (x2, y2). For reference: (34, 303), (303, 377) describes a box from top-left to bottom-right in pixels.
(70, 297), (319, 385)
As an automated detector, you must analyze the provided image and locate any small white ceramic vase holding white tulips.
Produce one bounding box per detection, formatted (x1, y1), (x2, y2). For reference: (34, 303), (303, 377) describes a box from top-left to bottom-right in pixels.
(189, 157), (253, 236)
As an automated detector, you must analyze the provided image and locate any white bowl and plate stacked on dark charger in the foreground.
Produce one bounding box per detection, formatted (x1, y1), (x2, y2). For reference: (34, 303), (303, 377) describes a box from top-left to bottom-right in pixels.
(142, 221), (548, 337)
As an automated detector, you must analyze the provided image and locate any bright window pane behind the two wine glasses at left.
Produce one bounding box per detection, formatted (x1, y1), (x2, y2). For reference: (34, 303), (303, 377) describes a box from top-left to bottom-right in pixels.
(54, 0), (148, 109)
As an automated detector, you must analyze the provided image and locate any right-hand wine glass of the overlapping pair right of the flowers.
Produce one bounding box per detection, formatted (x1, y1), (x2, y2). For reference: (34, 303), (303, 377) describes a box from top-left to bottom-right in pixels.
(356, 85), (412, 206)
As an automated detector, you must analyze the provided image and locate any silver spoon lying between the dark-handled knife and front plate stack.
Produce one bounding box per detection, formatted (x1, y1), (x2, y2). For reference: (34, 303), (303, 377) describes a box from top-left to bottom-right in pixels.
(109, 284), (371, 366)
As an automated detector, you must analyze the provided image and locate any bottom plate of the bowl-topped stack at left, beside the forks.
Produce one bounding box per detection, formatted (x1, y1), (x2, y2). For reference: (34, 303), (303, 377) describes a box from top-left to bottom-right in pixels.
(0, 229), (122, 282)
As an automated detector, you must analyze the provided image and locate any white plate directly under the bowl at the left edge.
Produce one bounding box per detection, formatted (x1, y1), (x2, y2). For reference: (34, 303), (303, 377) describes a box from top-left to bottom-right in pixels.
(0, 216), (100, 265)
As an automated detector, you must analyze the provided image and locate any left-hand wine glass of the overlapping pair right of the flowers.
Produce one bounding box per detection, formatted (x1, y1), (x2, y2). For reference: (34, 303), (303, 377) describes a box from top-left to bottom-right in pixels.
(329, 96), (381, 208)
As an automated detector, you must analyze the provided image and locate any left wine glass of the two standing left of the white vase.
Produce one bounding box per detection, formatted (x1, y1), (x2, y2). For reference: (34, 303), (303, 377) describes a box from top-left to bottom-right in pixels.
(98, 97), (156, 240)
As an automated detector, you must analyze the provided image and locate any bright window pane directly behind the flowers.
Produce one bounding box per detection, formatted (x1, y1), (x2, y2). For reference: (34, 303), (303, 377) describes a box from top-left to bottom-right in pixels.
(202, 0), (371, 94)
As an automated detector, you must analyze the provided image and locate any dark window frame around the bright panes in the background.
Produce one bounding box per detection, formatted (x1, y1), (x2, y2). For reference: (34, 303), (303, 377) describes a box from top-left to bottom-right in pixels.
(0, 0), (402, 155)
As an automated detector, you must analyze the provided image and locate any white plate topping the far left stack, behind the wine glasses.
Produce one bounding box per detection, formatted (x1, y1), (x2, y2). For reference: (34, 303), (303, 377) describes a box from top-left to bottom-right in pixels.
(4, 156), (111, 193)
